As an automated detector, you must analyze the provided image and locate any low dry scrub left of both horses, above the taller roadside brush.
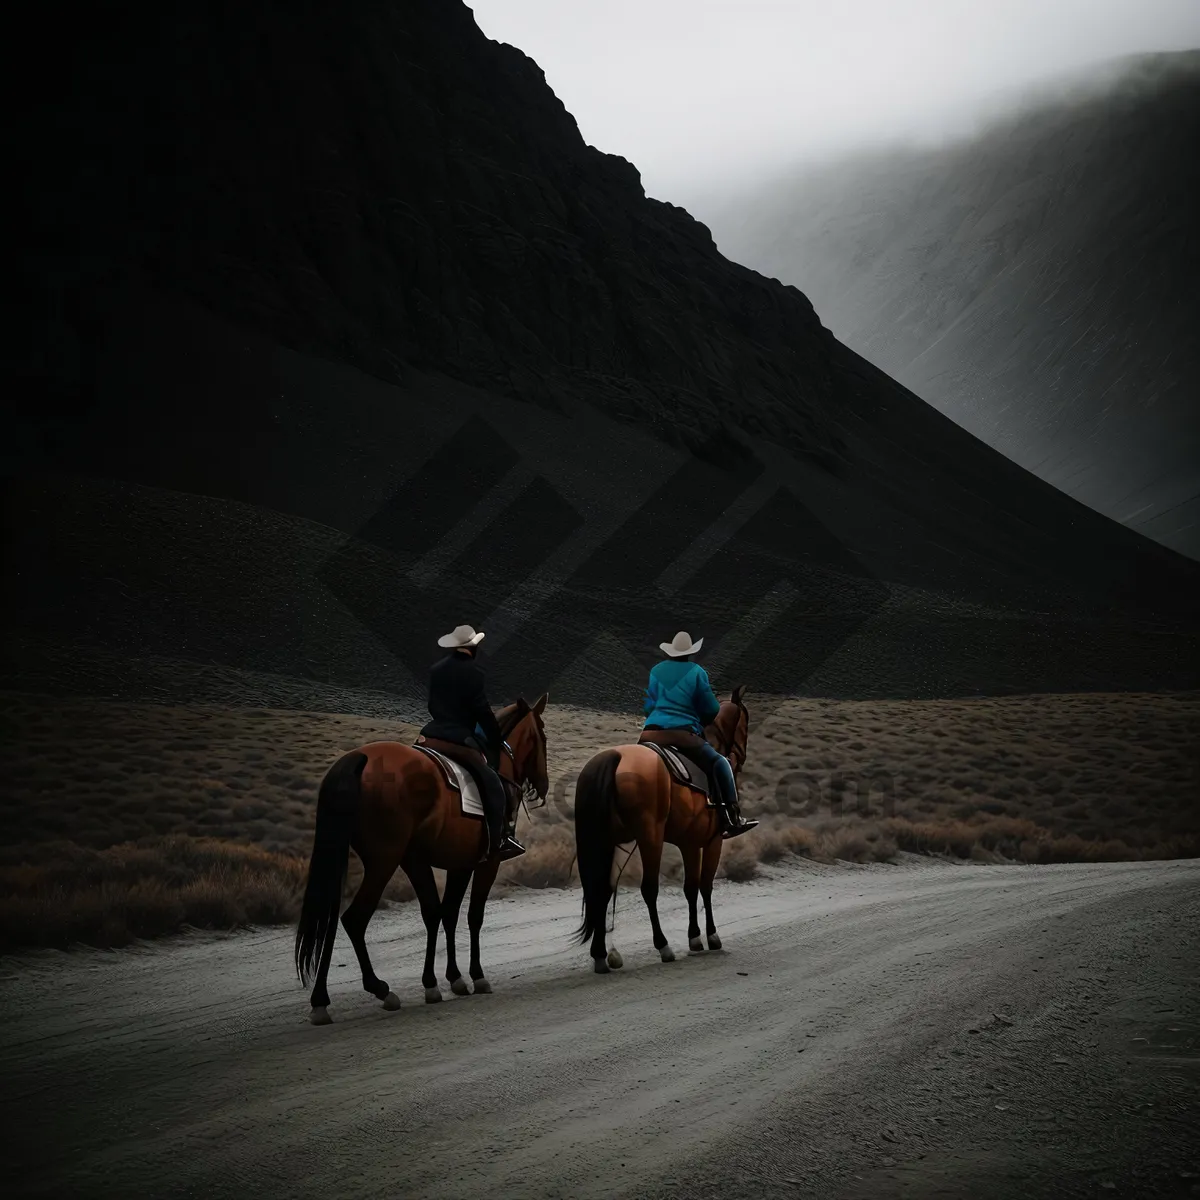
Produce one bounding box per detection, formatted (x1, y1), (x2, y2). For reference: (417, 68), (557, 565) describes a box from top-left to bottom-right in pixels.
(0, 694), (415, 858)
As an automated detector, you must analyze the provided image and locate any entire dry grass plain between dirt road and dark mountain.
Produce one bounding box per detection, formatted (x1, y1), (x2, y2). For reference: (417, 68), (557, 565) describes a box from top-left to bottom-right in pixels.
(0, 694), (1200, 947)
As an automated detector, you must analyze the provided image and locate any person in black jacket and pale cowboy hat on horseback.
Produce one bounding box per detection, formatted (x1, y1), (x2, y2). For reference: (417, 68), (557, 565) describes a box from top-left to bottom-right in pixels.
(421, 625), (524, 859)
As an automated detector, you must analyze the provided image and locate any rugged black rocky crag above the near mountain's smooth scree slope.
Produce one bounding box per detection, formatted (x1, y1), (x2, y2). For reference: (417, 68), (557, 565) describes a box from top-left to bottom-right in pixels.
(11, 0), (836, 470)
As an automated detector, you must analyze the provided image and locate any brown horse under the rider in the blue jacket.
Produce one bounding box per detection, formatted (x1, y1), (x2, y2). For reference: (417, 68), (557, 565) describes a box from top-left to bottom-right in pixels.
(575, 686), (750, 974)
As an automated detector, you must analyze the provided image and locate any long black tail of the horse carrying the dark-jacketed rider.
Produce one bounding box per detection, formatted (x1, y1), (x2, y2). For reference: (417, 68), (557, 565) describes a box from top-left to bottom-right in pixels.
(295, 750), (367, 988)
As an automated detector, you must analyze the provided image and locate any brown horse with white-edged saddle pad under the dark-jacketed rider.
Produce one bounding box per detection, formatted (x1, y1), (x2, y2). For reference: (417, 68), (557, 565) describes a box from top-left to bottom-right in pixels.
(295, 696), (550, 1025)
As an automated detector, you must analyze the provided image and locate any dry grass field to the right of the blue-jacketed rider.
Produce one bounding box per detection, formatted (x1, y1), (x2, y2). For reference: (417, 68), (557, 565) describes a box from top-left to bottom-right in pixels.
(729, 692), (1200, 863)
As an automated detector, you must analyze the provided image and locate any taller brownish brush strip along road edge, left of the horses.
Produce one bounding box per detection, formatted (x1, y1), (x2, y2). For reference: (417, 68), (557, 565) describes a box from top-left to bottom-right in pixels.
(0, 835), (307, 952)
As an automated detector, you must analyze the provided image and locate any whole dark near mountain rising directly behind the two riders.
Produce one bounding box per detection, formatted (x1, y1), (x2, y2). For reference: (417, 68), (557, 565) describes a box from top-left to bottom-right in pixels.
(5, 0), (1200, 707)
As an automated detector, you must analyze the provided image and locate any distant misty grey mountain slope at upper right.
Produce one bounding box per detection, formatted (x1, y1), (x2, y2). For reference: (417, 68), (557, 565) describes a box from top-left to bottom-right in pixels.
(709, 52), (1200, 557)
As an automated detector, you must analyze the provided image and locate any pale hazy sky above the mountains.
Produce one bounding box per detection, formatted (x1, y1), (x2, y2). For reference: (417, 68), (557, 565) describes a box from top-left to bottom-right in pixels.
(467, 0), (1200, 202)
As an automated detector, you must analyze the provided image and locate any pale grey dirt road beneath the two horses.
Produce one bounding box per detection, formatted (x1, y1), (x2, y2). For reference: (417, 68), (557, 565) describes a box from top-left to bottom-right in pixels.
(0, 862), (1200, 1200)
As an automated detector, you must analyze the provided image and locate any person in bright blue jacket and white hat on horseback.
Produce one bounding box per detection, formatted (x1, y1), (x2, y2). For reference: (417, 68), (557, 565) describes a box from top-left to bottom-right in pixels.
(638, 632), (758, 838)
